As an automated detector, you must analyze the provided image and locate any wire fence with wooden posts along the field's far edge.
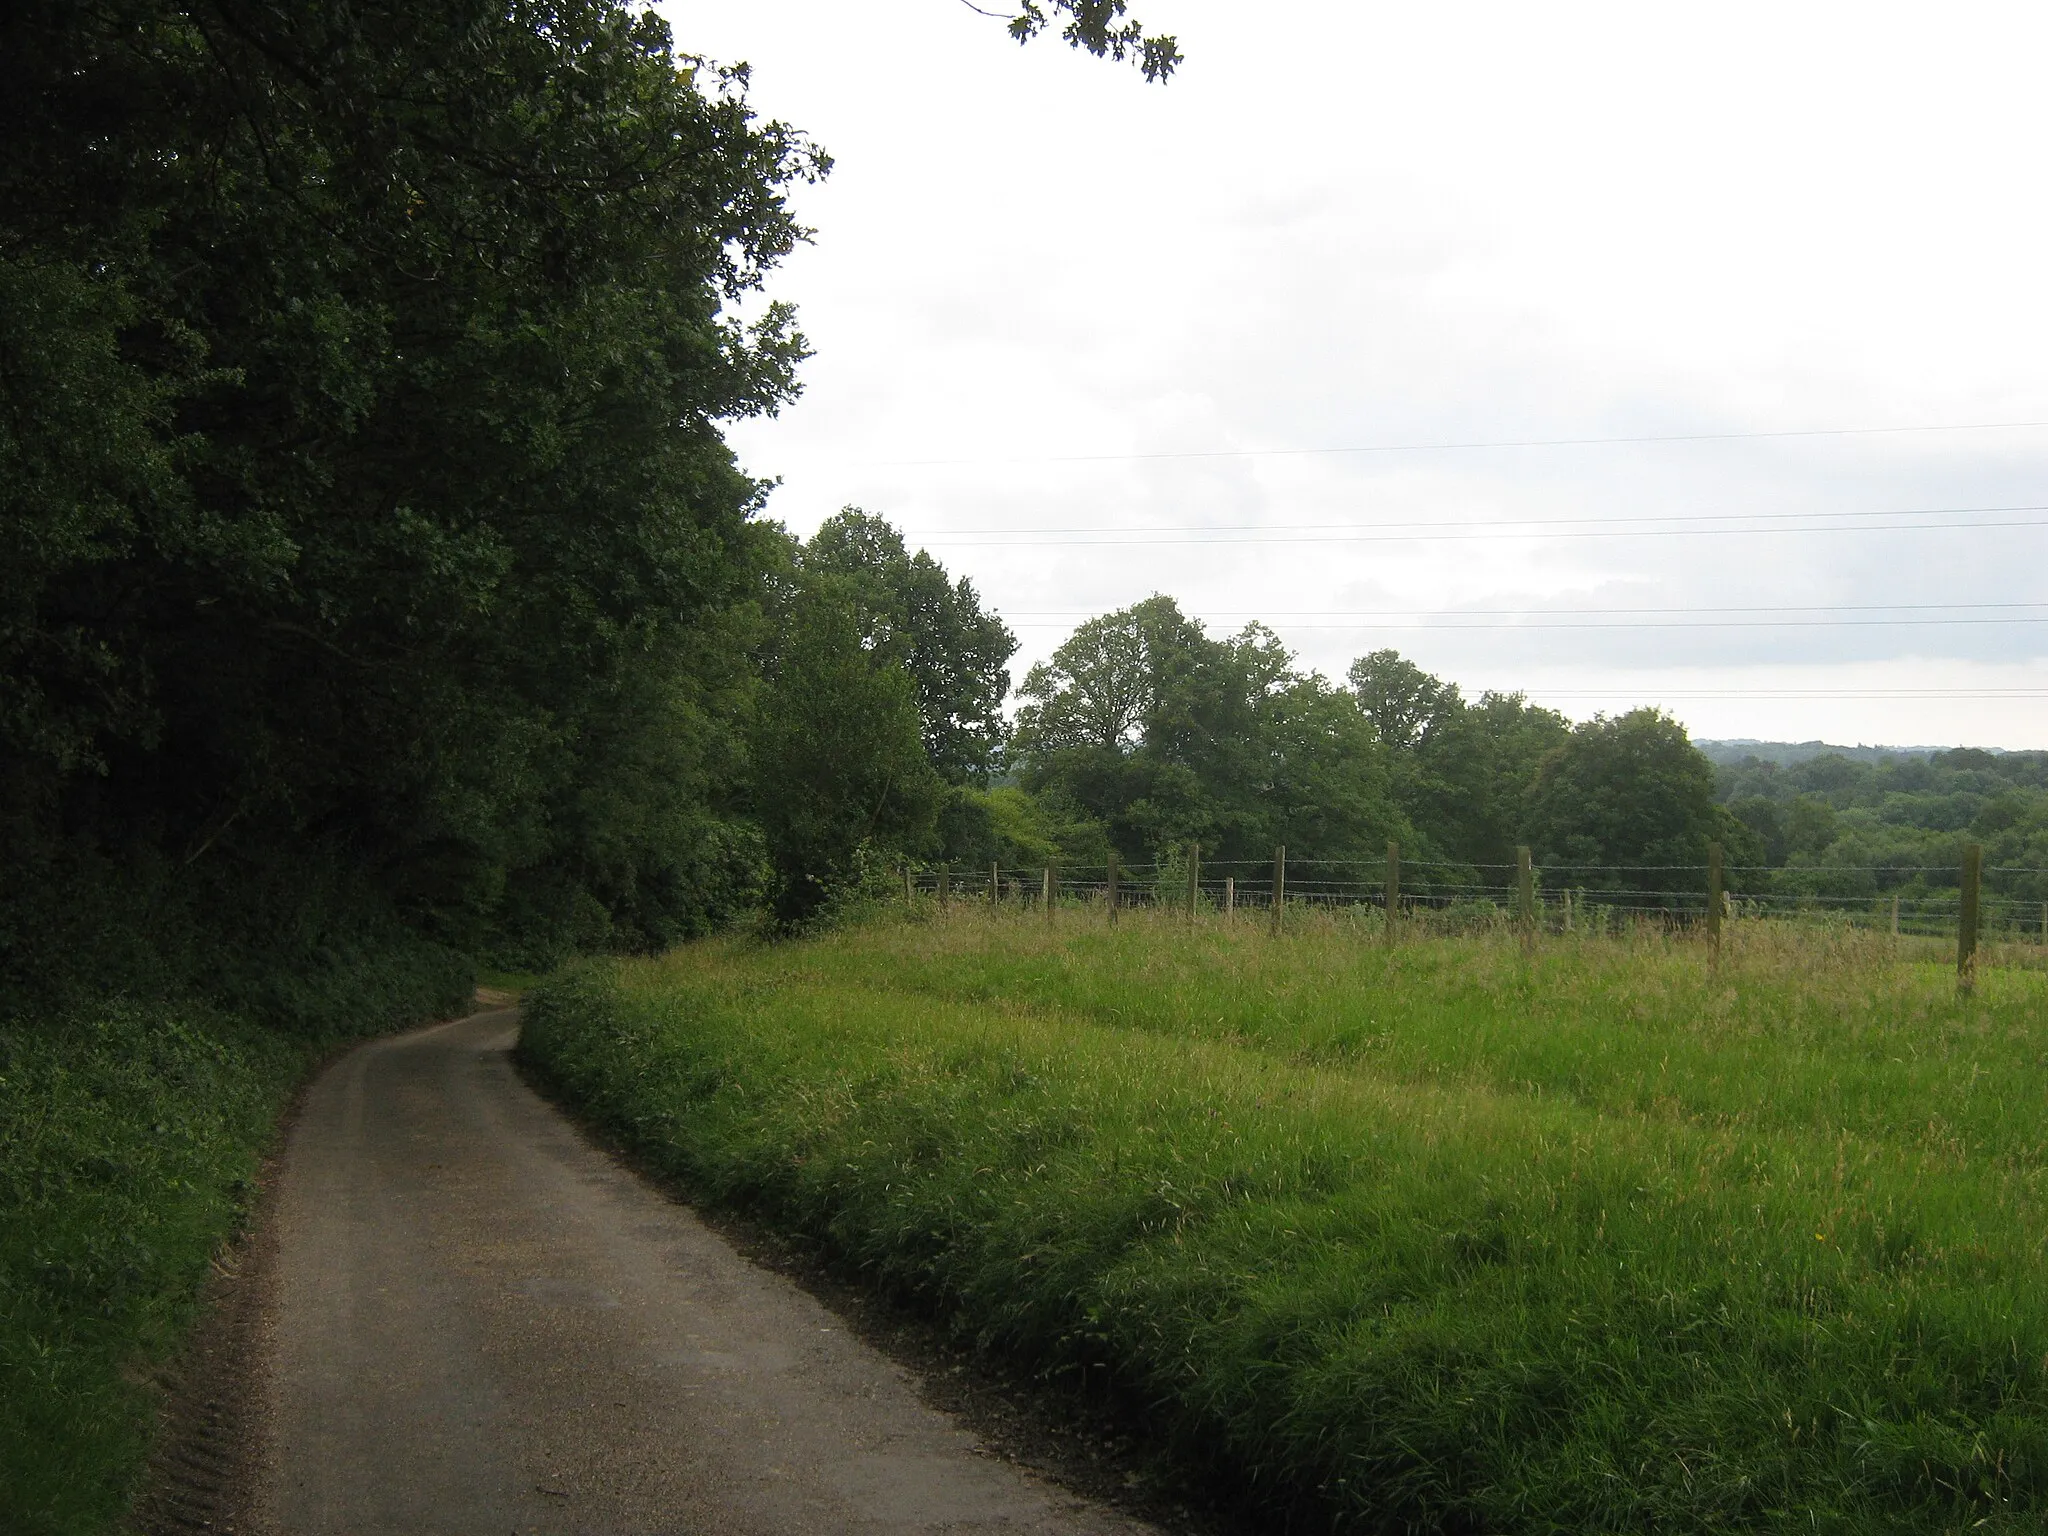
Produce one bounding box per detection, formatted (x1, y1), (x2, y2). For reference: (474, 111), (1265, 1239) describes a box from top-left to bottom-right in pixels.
(903, 858), (2048, 944)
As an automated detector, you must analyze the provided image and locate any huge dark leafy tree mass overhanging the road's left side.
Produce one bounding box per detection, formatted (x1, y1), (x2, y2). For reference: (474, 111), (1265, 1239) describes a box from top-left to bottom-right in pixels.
(0, 0), (827, 962)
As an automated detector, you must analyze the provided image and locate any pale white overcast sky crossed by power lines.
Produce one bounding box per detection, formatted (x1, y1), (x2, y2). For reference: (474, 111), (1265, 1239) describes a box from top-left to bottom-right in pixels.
(664, 0), (2048, 748)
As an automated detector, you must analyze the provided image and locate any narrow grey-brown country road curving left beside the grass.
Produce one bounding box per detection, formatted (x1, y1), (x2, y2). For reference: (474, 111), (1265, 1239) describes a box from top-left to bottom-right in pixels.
(256, 1010), (1143, 1536)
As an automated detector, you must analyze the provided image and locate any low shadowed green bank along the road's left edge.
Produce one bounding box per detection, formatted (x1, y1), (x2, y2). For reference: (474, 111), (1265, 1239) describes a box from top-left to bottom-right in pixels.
(0, 944), (467, 1536)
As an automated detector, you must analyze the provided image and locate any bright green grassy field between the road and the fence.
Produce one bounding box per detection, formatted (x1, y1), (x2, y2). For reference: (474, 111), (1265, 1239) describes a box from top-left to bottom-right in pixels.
(522, 907), (2048, 1532)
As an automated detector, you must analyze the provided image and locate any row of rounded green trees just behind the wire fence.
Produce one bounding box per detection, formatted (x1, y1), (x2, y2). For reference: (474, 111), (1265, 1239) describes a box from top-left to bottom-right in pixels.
(1012, 622), (1761, 891)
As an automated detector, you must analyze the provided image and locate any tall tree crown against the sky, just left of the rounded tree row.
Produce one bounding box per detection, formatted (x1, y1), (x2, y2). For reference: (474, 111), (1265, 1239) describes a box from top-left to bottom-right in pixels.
(801, 506), (1018, 784)
